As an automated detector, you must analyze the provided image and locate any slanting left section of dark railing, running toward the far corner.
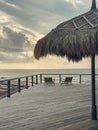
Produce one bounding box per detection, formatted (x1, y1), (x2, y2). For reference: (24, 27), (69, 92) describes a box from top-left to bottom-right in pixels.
(0, 74), (39, 98)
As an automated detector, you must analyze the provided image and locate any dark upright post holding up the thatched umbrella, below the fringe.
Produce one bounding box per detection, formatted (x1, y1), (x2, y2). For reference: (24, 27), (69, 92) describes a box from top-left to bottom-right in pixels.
(91, 54), (97, 120)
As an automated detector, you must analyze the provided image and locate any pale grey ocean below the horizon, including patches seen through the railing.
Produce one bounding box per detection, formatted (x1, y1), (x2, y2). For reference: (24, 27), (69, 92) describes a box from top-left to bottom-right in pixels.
(0, 69), (98, 82)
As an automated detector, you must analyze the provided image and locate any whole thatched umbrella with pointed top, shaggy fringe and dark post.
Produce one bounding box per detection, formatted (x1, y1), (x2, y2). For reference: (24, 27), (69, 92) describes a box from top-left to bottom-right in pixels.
(34, 0), (98, 120)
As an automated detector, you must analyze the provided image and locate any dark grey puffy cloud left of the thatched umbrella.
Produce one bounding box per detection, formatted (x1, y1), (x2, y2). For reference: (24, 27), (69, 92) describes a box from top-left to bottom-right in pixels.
(2, 27), (31, 52)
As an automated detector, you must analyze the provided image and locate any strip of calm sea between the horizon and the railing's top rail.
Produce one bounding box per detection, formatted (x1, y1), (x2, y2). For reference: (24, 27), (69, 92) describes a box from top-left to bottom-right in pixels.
(0, 69), (98, 78)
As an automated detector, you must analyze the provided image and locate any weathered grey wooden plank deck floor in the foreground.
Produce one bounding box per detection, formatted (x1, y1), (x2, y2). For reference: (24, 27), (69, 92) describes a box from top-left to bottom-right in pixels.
(0, 84), (98, 130)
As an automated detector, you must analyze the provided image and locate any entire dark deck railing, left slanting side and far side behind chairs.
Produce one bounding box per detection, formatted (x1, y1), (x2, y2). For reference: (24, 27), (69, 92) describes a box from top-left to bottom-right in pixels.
(0, 73), (98, 98)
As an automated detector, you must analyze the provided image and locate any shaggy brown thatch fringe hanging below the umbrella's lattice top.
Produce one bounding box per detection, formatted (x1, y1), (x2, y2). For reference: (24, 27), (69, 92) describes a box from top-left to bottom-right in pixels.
(34, 29), (98, 62)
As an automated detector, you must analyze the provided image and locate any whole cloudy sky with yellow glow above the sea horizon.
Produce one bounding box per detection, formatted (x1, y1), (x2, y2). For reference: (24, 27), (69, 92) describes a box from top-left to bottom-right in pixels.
(0, 0), (98, 69)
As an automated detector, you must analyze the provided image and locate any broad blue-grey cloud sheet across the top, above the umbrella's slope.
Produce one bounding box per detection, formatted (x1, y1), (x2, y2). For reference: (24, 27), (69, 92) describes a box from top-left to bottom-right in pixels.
(0, 0), (89, 34)
